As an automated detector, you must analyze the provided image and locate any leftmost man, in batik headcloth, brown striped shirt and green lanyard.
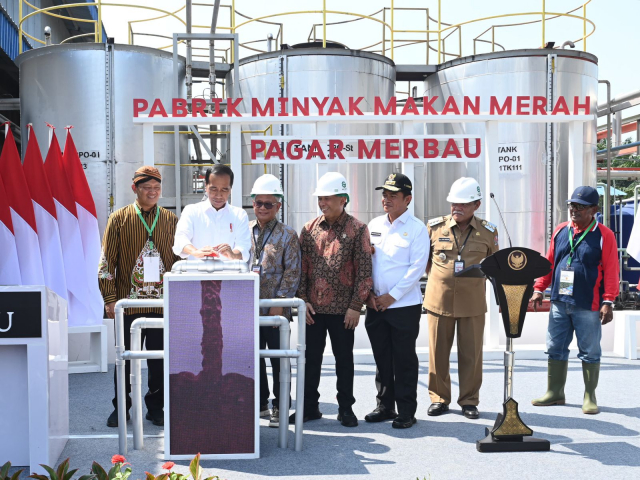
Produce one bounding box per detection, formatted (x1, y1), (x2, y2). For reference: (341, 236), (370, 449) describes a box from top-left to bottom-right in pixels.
(98, 166), (180, 427)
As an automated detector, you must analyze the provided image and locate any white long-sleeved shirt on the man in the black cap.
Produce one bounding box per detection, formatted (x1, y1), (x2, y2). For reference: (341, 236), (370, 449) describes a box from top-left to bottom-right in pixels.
(369, 210), (431, 308)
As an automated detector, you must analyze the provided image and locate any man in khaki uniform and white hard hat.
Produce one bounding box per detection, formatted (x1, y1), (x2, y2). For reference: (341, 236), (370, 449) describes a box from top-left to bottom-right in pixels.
(423, 177), (498, 419)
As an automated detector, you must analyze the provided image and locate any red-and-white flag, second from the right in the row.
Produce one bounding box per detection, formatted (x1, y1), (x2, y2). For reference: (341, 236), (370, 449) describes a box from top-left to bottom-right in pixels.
(44, 132), (94, 327)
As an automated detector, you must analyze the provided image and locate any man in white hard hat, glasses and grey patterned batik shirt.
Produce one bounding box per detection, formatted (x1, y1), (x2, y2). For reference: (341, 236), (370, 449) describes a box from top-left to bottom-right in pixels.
(249, 174), (301, 427)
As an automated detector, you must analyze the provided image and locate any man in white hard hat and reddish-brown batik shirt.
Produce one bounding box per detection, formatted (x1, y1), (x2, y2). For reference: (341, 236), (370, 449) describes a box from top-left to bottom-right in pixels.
(291, 172), (373, 427)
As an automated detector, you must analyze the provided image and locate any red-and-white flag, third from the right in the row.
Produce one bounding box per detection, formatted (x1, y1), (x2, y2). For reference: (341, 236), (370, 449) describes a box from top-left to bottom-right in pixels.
(22, 125), (68, 300)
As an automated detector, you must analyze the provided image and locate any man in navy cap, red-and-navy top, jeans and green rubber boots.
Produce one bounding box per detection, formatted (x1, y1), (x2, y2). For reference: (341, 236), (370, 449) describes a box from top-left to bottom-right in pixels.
(531, 187), (619, 414)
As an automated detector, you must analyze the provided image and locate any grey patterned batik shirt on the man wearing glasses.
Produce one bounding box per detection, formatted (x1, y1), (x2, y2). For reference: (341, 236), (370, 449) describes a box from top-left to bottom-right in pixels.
(249, 219), (302, 320)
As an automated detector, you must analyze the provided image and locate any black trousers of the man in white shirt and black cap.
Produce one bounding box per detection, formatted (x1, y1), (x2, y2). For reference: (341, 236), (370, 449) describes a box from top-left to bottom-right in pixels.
(364, 305), (422, 415)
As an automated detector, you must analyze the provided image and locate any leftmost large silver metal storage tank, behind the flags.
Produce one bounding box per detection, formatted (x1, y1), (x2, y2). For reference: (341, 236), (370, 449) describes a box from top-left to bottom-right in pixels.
(16, 43), (187, 234)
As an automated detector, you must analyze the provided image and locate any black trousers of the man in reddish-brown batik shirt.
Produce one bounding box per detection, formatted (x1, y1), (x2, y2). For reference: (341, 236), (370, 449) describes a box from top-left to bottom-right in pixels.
(304, 313), (356, 411)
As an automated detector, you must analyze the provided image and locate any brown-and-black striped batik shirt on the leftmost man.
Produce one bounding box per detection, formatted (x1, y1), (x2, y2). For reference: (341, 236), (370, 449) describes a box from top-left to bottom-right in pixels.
(98, 201), (180, 314)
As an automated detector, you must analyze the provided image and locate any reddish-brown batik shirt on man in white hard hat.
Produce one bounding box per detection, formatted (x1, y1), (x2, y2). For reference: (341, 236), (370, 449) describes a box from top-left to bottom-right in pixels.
(298, 212), (373, 315)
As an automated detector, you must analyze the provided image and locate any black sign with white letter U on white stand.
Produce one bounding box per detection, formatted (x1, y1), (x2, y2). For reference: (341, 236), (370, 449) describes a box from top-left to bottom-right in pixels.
(0, 292), (42, 339)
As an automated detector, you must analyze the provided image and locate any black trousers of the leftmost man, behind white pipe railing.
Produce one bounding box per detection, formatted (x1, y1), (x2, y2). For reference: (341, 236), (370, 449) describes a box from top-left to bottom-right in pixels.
(111, 313), (164, 412)
